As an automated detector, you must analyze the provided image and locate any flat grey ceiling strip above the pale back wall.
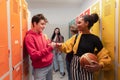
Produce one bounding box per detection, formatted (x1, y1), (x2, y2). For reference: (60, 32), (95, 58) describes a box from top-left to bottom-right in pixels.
(26, 0), (85, 8)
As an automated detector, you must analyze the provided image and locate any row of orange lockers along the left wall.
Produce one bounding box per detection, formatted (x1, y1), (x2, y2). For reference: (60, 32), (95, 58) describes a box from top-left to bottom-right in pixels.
(0, 0), (28, 80)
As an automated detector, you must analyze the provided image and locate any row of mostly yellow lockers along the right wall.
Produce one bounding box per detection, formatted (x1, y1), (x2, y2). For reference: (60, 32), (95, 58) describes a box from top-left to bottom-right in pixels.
(69, 0), (120, 80)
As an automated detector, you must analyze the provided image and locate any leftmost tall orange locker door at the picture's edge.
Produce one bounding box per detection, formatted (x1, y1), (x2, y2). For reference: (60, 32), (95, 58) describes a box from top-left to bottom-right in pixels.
(0, 0), (9, 77)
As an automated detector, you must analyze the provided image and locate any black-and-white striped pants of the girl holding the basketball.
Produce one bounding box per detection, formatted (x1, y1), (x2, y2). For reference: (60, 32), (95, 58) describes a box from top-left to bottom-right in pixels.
(71, 55), (93, 80)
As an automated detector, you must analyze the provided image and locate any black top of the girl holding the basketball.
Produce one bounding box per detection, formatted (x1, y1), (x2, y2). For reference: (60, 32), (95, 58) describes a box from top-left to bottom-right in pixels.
(76, 34), (103, 56)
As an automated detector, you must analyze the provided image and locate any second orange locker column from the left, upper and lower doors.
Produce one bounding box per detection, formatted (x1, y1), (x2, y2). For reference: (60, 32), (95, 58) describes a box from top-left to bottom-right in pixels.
(10, 0), (22, 80)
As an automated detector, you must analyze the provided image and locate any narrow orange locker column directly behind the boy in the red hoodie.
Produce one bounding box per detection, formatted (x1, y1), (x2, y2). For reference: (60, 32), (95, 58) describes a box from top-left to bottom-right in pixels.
(22, 0), (29, 80)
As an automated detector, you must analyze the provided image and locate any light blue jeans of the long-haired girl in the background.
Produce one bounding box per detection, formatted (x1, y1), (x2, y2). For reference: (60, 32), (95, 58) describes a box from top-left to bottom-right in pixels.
(53, 51), (65, 73)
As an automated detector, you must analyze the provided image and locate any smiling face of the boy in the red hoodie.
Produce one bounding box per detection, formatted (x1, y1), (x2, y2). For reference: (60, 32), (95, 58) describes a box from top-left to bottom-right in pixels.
(34, 19), (46, 33)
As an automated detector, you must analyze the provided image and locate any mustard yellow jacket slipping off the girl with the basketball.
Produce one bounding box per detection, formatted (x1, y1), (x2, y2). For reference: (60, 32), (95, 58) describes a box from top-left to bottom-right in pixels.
(59, 34), (112, 70)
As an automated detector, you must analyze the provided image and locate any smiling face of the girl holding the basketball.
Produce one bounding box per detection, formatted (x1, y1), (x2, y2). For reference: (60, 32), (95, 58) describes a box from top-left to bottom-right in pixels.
(76, 17), (88, 32)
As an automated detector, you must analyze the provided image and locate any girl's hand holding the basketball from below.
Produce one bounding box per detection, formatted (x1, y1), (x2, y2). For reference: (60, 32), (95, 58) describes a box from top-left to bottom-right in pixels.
(84, 61), (102, 72)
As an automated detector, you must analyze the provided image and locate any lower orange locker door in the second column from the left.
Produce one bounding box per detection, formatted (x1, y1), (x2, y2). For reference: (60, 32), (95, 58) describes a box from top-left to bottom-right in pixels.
(13, 64), (22, 80)
